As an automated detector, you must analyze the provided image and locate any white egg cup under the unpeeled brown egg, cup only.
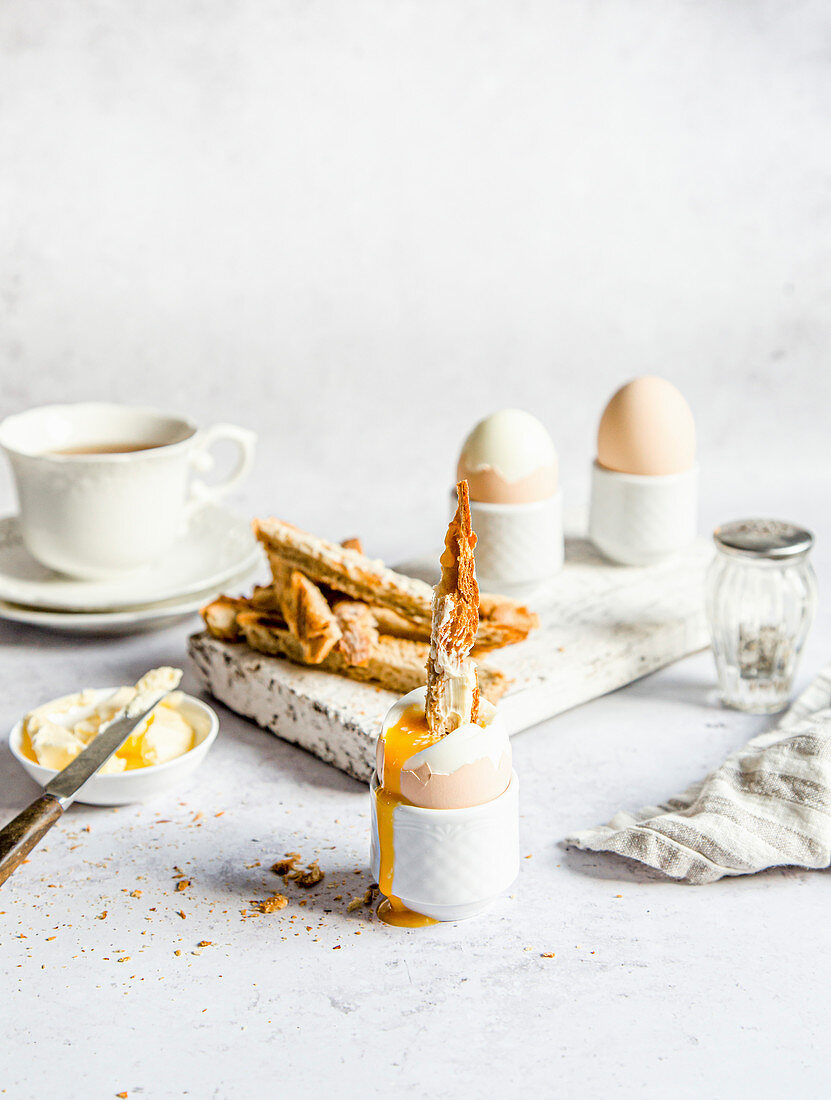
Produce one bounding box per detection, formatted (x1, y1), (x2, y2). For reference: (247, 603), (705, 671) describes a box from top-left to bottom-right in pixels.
(589, 462), (698, 565)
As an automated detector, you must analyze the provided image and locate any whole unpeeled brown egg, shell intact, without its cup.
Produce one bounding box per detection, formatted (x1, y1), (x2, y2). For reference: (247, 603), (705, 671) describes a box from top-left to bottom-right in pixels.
(598, 375), (696, 476)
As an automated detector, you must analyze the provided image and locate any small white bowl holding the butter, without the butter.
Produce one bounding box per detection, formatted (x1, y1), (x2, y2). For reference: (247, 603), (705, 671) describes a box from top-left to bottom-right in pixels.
(9, 688), (219, 806)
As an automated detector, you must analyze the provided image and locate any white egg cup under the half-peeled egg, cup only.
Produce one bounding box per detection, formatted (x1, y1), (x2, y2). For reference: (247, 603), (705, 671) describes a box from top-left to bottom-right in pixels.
(468, 490), (565, 594)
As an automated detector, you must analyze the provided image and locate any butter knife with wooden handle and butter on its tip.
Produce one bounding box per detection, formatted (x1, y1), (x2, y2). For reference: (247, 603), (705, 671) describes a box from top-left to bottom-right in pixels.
(0, 691), (170, 886)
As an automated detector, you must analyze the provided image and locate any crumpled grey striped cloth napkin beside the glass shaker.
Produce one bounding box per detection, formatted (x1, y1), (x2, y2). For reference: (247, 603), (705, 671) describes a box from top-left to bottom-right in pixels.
(566, 664), (831, 883)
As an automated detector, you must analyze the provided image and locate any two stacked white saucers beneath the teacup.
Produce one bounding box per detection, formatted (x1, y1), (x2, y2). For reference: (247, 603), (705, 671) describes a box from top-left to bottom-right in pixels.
(0, 505), (262, 634)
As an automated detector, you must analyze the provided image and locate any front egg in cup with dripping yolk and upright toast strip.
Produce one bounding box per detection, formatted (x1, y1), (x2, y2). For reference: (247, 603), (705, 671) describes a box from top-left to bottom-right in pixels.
(370, 481), (518, 927)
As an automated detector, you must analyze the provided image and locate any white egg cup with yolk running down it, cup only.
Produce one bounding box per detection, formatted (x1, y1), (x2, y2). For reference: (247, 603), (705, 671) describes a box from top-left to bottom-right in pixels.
(370, 772), (520, 921)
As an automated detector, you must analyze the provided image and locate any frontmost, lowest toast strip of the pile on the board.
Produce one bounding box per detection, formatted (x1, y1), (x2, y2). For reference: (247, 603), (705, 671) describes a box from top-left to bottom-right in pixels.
(231, 612), (511, 703)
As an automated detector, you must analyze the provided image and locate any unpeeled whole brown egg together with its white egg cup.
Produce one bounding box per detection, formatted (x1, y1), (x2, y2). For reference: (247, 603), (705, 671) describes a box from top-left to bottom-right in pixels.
(589, 376), (698, 565)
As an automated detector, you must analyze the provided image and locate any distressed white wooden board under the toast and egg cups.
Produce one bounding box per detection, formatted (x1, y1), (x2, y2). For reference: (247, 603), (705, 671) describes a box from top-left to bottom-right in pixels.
(189, 538), (712, 780)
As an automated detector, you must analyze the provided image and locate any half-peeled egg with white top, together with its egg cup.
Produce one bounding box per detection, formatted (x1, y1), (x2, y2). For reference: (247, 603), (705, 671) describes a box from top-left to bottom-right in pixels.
(457, 409), (564, 595)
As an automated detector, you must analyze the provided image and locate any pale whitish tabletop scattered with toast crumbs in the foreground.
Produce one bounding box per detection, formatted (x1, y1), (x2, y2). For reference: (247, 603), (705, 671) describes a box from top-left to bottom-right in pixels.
(0, 473), (831, 1098)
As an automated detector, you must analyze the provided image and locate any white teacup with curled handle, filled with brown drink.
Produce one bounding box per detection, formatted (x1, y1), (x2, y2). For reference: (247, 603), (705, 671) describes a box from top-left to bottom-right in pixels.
(0, 403), (256, 580)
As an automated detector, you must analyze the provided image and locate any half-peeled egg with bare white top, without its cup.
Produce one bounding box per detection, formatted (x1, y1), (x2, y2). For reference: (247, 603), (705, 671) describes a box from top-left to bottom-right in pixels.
(456, 409), (558, 504)
